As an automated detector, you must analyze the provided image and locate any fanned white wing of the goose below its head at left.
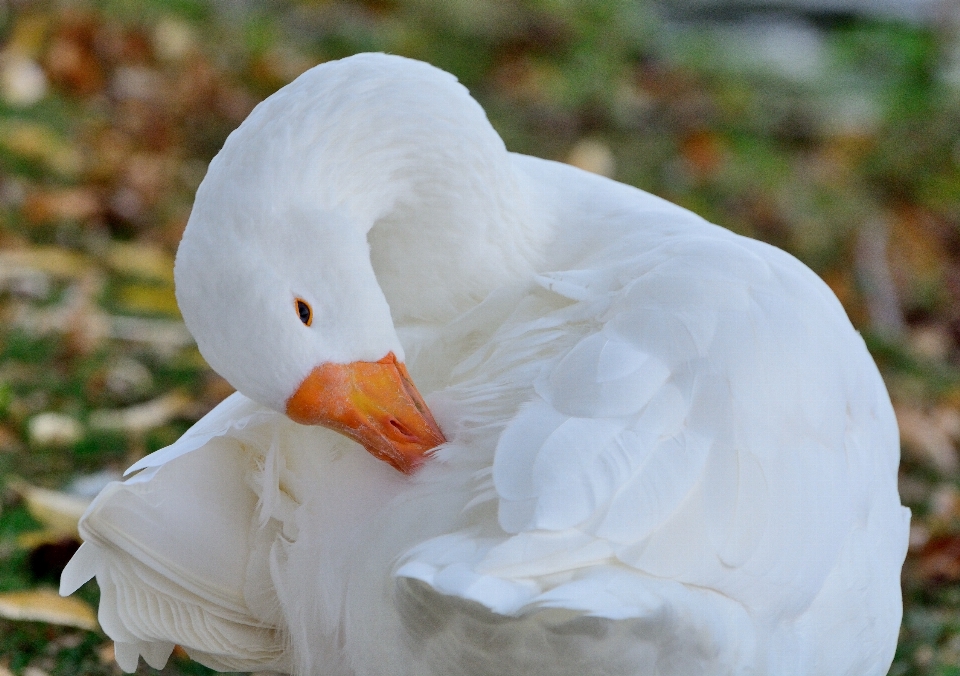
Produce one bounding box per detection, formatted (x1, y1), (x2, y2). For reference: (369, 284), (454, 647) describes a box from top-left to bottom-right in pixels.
(60, 395), (289, 671)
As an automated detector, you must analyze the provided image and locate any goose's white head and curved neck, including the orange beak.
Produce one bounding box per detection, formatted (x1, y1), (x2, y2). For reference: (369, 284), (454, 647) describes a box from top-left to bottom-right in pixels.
(175, 54), (530, 472)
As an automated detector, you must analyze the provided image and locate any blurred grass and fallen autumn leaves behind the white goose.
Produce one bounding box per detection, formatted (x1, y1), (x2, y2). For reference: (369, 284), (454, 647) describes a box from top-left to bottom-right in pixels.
(0, 0), (960, 676)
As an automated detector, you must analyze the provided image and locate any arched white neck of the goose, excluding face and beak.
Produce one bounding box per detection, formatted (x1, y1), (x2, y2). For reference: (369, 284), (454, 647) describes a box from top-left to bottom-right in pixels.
(206, 55), (544, 323)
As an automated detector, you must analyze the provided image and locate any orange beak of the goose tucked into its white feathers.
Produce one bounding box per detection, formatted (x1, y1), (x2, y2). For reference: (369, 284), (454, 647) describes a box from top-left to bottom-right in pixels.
(287, 352), (446, 474)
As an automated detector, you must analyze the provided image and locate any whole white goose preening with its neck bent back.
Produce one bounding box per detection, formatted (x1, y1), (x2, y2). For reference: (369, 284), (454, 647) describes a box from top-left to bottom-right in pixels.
(61, 53), (910, 676)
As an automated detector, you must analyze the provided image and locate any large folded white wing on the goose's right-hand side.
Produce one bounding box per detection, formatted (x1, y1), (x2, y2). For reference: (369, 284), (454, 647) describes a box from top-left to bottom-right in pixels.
(397, 223), (909, 674)
